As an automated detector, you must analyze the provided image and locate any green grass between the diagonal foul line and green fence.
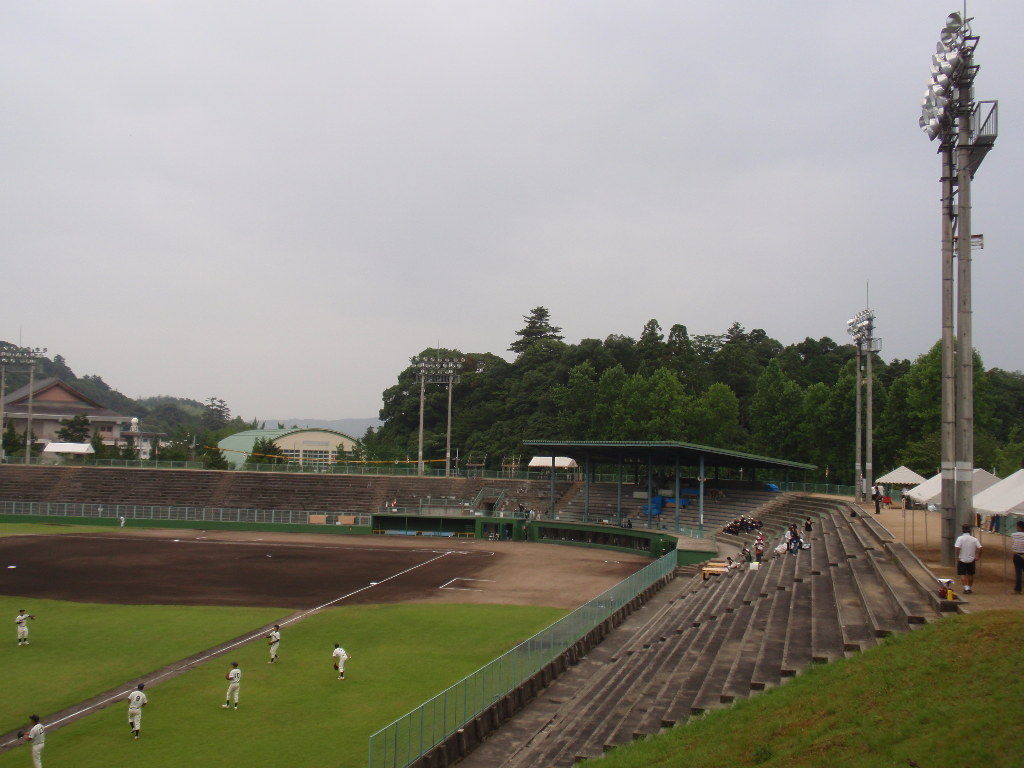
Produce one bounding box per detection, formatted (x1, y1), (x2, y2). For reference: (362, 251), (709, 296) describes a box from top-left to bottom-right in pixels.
(0, 604), (565, 768)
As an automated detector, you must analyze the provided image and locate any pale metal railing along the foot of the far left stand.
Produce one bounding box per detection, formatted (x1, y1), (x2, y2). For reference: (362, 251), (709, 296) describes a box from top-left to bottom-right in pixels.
(0, 501), (370, 526)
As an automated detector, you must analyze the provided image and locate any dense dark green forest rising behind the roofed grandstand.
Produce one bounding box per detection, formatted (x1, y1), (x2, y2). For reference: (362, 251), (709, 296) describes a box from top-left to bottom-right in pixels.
(362, 307), (1024, 483)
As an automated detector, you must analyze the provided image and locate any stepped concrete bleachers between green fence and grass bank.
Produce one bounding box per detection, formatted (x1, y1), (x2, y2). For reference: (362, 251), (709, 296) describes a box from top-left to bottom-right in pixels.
(487, 497), (957, 768)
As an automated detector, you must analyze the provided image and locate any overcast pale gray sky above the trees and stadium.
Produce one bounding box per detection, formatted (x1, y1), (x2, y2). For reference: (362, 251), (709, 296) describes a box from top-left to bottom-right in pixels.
(0, 0), (1024, 418)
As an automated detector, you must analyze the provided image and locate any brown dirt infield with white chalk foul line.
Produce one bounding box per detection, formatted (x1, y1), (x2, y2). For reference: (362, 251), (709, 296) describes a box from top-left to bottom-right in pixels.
(0, 529), (650, 609)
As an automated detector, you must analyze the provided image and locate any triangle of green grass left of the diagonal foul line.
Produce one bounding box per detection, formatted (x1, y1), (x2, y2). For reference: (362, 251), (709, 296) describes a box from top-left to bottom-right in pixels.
(0, 596), (292, 733)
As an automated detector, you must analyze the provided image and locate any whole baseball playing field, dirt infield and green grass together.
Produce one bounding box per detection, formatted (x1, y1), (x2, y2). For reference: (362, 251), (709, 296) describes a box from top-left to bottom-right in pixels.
(0, 525), (648, 768)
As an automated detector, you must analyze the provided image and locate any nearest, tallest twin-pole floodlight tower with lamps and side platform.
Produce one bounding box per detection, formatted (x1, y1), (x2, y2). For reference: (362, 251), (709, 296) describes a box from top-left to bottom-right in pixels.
(919, 12), (999, 565)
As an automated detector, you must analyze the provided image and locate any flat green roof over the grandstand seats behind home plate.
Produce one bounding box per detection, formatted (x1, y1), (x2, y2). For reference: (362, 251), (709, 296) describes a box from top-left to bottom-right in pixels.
(523, 440), (817, 469)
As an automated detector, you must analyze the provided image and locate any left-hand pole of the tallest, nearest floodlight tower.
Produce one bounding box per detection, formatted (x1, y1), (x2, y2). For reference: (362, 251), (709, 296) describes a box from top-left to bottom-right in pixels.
(926, 144), (957, 566)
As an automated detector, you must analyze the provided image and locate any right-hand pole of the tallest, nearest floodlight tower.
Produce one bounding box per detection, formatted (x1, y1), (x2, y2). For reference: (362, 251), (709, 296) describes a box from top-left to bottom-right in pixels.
(955, 60), (974, 525)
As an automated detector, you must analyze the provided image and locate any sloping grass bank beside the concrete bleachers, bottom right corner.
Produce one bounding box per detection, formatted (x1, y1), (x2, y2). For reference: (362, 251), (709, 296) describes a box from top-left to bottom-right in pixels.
(582, 611), (1024, 768)
